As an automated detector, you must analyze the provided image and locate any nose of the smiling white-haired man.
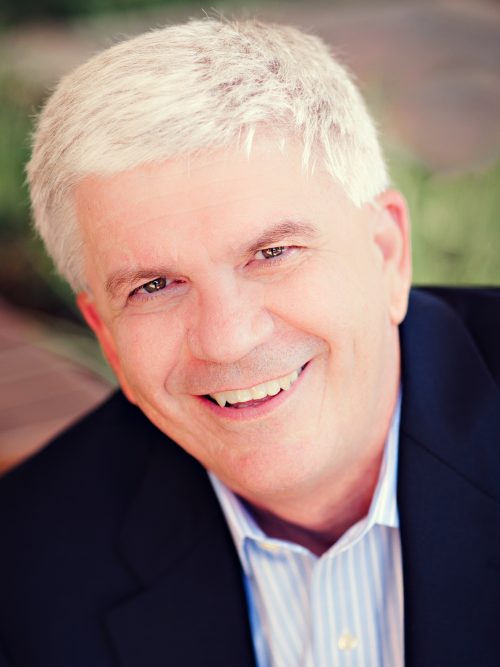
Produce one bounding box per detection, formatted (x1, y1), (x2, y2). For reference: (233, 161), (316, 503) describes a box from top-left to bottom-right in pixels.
(187, 281), (274, 364)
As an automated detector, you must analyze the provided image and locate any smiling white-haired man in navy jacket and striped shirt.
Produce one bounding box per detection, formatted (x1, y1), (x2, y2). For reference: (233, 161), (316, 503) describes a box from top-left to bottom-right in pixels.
(0, 15), (500, 667)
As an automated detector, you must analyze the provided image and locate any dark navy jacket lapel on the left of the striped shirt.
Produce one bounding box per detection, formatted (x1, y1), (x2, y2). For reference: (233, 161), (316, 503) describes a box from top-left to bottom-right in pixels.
(107, 434), (255, 667)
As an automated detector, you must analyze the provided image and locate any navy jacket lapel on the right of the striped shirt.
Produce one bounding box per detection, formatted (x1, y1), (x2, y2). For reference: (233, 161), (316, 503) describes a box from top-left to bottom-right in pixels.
(398, 293), (500, 667)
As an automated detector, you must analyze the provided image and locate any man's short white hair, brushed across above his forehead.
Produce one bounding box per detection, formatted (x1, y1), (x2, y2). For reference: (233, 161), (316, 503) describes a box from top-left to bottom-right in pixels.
(27, 18), (388, 291)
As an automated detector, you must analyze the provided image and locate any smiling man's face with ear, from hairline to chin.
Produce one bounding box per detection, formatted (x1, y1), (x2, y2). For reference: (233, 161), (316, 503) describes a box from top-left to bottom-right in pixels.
(75, 141), (409, 505)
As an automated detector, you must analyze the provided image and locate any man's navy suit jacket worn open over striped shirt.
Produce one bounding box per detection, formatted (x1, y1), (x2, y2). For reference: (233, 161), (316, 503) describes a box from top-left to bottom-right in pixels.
(0, 289), (500, 667)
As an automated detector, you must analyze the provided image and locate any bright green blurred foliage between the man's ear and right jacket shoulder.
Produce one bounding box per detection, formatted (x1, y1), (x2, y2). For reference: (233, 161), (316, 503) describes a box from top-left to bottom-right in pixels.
(390, 154), (500, 285)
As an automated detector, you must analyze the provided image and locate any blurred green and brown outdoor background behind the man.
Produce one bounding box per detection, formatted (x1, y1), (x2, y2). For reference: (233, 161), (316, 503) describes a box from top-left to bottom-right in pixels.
(0, 0), (500, 471)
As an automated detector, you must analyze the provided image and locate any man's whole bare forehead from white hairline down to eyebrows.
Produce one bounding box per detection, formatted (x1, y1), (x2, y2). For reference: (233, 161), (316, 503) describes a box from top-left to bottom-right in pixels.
(75, 141), (354, 288)
